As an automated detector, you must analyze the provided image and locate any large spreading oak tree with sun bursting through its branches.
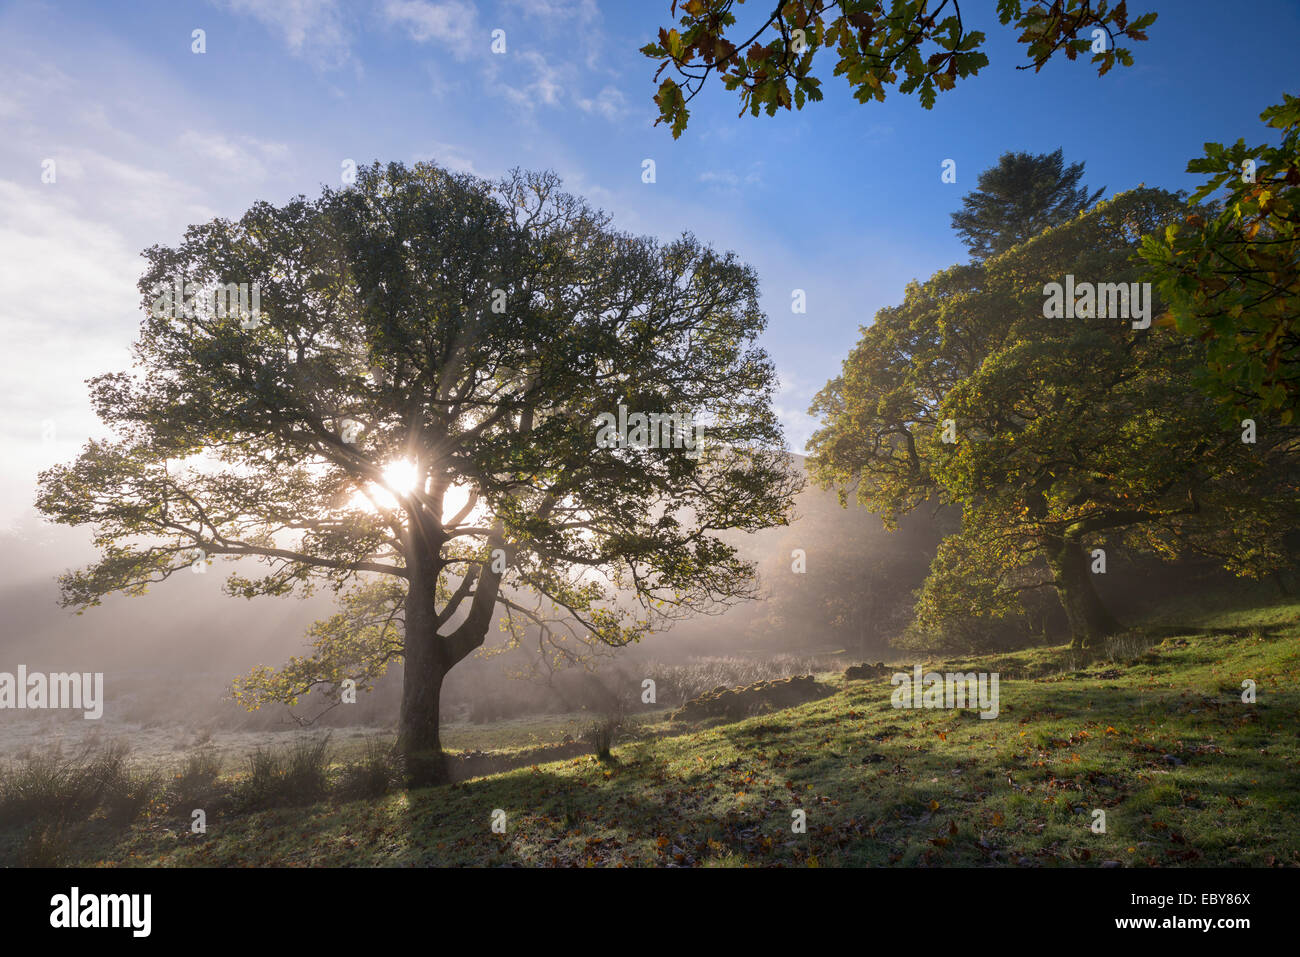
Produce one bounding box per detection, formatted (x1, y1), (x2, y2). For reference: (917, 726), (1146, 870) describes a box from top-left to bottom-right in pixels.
(38, 164), (800, 779)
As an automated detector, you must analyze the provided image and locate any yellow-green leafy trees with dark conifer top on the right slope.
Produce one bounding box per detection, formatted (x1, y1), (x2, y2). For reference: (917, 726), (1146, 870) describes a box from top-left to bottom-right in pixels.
(810, 151), (1300, 649)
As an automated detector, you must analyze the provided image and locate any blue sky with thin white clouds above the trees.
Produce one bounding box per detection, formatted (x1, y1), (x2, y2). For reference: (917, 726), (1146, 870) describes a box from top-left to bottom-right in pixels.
(0, 0), (1300, 521)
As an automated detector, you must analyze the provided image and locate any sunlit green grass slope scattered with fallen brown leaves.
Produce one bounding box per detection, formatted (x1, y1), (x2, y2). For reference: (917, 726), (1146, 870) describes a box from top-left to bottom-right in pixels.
(12, 603), (1300, 866)
